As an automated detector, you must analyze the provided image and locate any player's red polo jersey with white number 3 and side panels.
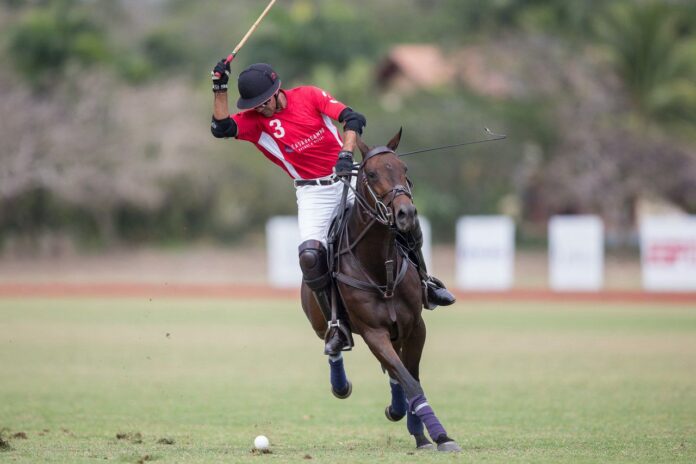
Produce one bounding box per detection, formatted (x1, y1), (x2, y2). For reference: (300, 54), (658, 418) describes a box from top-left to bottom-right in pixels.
(232, 86), (346, 179)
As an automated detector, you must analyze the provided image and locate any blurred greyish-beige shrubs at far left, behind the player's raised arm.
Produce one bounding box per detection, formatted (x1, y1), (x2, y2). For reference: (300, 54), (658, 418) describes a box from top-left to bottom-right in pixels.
(0, 68), (213, 243)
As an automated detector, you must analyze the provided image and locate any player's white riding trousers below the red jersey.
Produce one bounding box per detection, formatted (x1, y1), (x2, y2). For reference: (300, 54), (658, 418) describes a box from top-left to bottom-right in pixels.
(295, 177), (355, 246)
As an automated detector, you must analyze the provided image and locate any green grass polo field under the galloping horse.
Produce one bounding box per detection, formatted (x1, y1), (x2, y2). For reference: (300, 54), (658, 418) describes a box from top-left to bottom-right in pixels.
(0, 299), (696, 463)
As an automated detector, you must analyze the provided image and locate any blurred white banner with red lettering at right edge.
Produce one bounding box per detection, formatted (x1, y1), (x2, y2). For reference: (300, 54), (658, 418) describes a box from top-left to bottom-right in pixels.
(640, 216), (696, 291)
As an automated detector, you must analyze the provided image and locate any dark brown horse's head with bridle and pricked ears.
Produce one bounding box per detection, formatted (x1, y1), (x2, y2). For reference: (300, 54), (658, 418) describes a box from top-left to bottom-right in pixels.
(357, 129), (417, 232)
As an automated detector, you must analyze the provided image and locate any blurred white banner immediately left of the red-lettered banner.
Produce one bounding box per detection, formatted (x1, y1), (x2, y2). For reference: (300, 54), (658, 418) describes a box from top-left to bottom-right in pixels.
(549, 215), (604, 291)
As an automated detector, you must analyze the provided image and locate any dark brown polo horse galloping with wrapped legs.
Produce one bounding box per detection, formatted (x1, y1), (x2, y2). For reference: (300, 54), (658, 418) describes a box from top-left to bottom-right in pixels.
(301, 131), (461, 451)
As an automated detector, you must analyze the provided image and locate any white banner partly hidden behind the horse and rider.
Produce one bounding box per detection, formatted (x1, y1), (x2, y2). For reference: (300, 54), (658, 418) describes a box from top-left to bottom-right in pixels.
(266, 216), (432, 288)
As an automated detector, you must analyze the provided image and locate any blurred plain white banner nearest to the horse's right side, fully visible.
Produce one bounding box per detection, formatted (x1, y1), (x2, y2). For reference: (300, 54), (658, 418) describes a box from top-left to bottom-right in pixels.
(456, 216), (515, 290)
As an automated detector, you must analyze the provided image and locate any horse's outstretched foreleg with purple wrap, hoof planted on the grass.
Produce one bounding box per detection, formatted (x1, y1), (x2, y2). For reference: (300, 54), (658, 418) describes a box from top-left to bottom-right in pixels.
(363, 330), (461, 451)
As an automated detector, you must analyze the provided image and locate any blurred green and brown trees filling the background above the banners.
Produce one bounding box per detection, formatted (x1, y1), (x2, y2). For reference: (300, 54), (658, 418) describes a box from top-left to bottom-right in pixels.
(0, 0), (696, 252)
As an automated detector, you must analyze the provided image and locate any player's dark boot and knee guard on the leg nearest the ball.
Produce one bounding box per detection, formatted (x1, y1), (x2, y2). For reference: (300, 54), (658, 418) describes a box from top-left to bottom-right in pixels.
(299, 240), (353, 356)
